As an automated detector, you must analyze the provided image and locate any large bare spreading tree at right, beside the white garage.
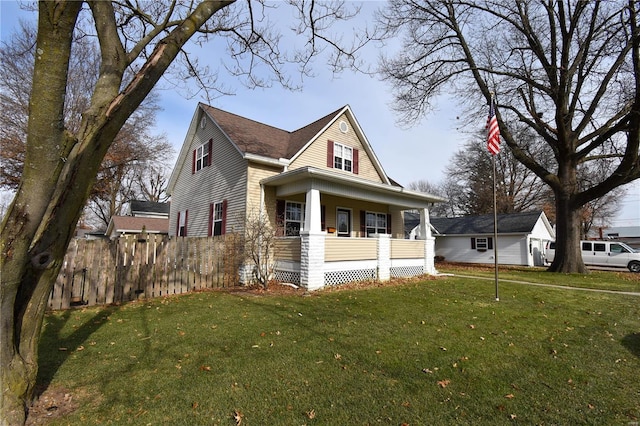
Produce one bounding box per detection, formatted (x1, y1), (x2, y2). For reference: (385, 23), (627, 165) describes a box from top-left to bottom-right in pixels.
(379, 0), (640, 272)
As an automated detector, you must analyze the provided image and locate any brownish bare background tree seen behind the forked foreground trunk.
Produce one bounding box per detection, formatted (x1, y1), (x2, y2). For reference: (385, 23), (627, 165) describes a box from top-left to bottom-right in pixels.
(0, 22), (173, 229)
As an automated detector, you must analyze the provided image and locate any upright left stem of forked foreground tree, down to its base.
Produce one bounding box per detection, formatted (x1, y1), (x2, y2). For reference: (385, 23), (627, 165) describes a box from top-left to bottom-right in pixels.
(0, 2), (82, 425)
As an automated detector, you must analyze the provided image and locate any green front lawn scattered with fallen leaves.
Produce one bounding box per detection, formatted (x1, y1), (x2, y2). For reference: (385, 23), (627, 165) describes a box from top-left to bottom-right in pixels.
(39, 271), (640, 425)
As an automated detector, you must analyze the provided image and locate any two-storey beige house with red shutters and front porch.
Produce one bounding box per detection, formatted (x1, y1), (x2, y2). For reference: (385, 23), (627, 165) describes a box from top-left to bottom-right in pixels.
(167, 104), (444, 289)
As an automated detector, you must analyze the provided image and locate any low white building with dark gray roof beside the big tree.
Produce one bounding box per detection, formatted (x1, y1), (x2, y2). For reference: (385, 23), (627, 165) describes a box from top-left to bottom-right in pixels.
(420, 211), (555, 266)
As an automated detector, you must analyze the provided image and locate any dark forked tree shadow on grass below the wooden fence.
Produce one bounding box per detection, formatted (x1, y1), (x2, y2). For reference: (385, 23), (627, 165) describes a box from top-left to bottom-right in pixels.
(34, 307), (117, 398)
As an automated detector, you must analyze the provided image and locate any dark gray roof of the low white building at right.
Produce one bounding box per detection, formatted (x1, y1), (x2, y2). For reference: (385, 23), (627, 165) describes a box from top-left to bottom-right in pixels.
(431, 211), (542, 235)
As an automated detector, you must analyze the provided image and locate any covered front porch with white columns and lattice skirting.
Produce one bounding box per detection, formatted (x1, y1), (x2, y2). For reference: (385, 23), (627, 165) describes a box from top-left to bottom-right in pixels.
(261, 167), (443, 290)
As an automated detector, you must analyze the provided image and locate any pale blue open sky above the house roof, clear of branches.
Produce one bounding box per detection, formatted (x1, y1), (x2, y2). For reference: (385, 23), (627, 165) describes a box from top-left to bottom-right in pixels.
(0, 0), (640, 226)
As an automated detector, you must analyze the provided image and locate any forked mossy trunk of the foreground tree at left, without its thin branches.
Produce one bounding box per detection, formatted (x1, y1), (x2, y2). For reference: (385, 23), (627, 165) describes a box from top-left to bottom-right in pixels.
(0, 0), (232, 426)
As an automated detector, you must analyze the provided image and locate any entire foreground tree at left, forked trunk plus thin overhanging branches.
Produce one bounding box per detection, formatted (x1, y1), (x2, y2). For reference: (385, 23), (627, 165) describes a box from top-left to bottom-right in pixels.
(0, 0), (370, 425)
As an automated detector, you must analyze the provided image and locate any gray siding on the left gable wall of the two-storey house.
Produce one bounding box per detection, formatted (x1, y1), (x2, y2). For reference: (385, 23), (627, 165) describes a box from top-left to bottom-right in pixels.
(169, 109), (247, 237)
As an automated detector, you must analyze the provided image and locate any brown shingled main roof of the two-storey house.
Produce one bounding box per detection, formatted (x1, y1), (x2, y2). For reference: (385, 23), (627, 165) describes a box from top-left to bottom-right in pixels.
(201, 104), (344, 159)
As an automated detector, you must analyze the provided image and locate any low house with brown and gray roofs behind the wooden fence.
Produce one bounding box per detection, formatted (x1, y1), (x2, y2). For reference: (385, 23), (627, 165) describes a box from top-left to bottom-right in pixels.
(105, 201), (169, 238)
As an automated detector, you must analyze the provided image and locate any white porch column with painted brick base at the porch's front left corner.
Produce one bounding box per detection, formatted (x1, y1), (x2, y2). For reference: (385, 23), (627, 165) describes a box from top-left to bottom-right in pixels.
(300, 189), (327, 290)
